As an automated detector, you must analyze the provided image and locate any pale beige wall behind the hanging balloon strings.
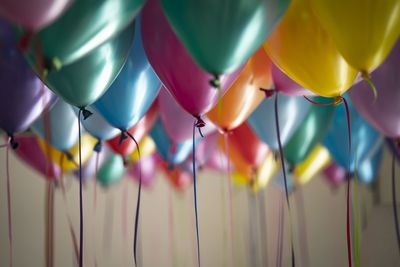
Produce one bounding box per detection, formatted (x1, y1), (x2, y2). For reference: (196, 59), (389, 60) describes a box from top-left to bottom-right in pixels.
(0, 150), (400, 267)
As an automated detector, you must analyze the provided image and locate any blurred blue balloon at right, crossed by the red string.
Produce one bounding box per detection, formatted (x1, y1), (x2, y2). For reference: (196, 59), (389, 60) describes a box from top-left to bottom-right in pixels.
(323, 96), (383, 172)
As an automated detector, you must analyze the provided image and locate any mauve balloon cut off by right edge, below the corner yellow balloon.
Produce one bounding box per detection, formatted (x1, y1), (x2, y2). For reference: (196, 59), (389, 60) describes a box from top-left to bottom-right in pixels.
(349, 42), (400, 137)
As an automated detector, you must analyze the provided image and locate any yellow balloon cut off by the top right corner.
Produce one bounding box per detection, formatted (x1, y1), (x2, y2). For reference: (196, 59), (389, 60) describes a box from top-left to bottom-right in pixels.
(310, 0), (400, 73)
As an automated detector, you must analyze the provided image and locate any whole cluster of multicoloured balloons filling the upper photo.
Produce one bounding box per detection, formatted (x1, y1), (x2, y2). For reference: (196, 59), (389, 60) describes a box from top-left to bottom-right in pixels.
(0, 0), (400, 193)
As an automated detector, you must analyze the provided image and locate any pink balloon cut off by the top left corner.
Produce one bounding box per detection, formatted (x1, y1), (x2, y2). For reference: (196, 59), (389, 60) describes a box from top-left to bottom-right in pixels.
(0, 0), (72, 31)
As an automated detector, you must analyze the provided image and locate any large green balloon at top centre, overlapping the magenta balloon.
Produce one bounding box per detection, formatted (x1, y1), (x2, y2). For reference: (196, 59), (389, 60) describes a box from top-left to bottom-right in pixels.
(161, 0), (290, 75)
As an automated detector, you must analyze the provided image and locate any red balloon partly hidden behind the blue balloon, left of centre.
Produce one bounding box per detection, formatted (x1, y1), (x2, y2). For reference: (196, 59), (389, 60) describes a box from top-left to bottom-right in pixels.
(107, 105), (157, 157)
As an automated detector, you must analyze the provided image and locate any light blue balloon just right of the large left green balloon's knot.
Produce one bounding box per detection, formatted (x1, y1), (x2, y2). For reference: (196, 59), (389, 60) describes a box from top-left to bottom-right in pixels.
(74, 106), (121, 141)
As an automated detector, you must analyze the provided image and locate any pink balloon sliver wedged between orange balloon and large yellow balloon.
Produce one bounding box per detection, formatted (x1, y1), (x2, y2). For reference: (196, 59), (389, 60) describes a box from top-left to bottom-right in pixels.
(272, 64), (314, 96)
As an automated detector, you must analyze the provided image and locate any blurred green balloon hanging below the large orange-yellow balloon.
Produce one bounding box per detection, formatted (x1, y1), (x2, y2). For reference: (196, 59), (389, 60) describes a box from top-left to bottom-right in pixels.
(283, 97), (335, 165)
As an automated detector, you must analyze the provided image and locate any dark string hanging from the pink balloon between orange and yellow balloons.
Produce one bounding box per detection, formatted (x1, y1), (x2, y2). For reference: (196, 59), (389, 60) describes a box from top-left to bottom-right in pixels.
(275, 94), (296, 267)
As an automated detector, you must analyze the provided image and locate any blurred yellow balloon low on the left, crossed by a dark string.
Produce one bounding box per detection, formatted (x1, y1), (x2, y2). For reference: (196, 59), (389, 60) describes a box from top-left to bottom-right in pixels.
(38, 134), (97, 172)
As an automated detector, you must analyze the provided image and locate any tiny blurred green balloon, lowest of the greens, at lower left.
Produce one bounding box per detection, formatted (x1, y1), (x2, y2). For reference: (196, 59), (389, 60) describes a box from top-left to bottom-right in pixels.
(96, 153), (125, 186)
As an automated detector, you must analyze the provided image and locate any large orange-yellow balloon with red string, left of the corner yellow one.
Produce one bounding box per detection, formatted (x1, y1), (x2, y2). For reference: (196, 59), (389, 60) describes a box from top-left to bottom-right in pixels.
(264, 0), (357, 97)
